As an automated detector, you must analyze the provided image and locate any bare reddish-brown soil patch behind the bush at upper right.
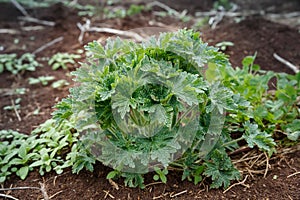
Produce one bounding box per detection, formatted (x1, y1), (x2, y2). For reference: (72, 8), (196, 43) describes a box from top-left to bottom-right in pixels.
(203, 17), (300, 73)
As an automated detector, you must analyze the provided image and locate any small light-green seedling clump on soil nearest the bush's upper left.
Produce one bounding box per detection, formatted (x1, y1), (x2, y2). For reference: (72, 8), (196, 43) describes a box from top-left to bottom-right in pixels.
(48, 53), (81, 70)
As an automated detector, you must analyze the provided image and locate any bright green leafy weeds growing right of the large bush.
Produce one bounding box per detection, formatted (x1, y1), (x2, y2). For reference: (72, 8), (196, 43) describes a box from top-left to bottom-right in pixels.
(214, 54), (300, 145)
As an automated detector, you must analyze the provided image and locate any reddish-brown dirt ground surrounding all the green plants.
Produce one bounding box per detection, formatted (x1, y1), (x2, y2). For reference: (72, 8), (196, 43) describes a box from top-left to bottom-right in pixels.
(0, 0), (300, 200)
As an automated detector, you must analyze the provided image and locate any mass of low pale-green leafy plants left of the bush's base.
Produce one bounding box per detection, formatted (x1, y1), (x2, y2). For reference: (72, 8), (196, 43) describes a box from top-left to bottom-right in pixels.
(0, 120), (95, 183)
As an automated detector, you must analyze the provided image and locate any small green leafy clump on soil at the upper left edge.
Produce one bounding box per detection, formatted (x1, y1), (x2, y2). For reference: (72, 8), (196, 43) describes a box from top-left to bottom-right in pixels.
(0, 53), (40, 74)
